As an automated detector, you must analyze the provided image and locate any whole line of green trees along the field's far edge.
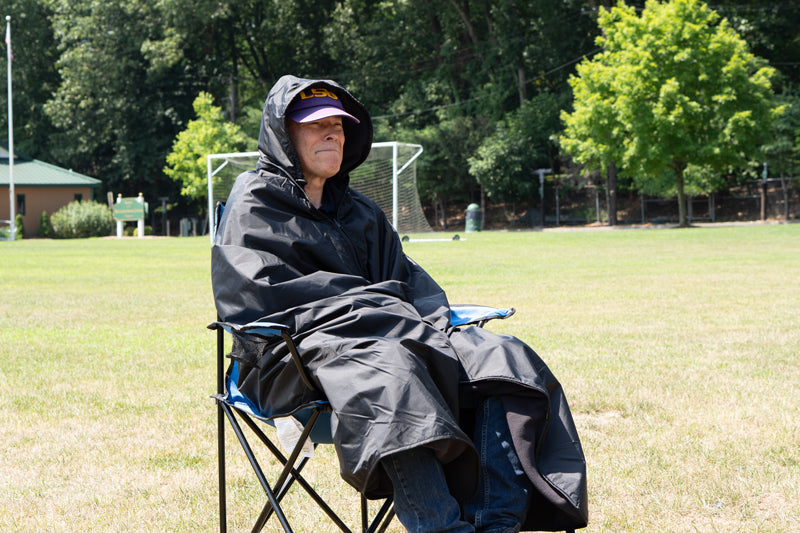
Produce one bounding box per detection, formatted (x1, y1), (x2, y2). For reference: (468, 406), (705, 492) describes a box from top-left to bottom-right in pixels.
(0, 0), (800, 225)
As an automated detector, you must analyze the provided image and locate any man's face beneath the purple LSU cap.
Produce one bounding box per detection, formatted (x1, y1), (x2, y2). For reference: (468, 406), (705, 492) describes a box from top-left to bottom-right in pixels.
(289, 117), (344, 181)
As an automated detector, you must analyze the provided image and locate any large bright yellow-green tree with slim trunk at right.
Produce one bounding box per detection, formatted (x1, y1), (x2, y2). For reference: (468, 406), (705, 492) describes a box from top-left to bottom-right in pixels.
(561, 0), (780, 226)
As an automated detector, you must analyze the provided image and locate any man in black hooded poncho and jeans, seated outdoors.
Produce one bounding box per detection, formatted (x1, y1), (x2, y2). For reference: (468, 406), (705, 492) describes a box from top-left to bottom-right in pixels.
(212, 76), (588, 532)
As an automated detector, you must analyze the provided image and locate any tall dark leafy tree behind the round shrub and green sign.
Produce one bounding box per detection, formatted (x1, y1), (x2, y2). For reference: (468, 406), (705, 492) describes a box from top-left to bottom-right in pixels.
(44, 0), (212, 196)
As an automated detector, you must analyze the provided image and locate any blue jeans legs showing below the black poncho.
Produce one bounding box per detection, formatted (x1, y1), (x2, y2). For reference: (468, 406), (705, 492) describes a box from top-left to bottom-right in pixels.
(381, 398), (531, 533)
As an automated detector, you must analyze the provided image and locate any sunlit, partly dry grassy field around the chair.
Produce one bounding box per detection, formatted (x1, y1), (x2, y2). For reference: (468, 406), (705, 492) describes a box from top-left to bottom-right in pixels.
(0, 224), (800, 533)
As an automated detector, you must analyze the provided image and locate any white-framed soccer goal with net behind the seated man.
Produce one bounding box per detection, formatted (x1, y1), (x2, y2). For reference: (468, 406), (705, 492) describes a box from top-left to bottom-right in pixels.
(206, 142), (433, 244)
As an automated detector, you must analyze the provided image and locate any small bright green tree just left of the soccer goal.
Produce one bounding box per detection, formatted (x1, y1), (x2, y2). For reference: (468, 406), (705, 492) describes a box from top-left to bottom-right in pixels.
(164, 92), (250, 207)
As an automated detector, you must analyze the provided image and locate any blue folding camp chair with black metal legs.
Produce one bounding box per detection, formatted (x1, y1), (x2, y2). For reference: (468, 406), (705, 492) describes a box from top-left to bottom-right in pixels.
(209, 305), (514, 533)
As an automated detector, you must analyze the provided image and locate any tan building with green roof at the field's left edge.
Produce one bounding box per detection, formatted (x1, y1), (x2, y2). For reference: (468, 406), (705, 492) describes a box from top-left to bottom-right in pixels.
(0, 146), (102, 237)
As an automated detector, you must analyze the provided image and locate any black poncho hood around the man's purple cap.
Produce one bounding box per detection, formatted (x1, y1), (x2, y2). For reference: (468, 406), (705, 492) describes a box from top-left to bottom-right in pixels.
(257, 75), (372, 190)
